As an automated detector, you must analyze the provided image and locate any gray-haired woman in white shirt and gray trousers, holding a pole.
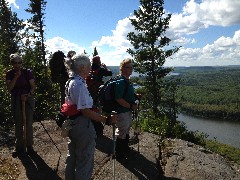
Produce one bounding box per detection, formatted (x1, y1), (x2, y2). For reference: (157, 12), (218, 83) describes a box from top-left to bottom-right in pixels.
(65, 54), (116, 180)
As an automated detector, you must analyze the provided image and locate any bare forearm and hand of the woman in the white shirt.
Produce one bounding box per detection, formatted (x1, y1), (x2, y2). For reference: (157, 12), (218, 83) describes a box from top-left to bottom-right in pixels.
(80, 108), (116, 124)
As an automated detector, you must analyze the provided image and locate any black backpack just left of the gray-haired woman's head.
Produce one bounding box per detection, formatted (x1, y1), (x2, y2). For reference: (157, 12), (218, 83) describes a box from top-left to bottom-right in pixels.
(49, 51), (68, 83)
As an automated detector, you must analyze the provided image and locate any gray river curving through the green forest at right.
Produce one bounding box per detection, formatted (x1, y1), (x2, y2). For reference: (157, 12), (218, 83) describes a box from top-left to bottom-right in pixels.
(178, 114), (240, 148)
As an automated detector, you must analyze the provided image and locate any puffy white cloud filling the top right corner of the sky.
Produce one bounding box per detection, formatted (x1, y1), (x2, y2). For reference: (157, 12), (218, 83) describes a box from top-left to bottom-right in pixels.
(169, 0), (240, 34)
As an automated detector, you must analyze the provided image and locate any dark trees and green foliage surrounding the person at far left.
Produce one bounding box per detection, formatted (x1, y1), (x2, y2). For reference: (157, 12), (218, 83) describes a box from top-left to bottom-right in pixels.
(0, 0), (60, 129)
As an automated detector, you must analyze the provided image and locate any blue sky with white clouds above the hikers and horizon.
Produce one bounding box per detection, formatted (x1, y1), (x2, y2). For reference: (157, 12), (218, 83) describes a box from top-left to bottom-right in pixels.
(8, 0), (240, 66)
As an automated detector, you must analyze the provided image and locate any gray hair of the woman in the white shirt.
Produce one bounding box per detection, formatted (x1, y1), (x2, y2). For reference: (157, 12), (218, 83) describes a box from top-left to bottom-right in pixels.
(65, 54), (90, 73)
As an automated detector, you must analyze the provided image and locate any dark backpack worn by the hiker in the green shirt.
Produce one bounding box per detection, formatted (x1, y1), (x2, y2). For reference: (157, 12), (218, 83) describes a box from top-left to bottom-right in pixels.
(98, 76), (129, 113)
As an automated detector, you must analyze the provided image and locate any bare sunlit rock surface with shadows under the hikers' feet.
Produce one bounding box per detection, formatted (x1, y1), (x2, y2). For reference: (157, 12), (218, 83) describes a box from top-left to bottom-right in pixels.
(0, 120), (240, 180)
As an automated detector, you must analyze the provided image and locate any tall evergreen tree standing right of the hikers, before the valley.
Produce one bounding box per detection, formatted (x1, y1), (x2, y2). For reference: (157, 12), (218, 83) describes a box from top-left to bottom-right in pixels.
(127, 0), (179, 144)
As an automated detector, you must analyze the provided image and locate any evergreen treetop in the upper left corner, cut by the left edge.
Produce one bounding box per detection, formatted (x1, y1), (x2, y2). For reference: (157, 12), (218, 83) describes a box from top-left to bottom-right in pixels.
(0, 0), (23, 66)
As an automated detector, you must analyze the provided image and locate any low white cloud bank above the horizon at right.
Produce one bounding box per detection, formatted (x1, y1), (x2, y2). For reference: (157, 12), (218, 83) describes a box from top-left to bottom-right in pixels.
(165, 30), (240, 66)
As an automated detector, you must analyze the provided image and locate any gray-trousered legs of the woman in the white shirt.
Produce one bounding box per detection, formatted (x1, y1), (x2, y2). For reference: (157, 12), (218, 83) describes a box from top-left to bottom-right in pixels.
(66, 116), (96, 180)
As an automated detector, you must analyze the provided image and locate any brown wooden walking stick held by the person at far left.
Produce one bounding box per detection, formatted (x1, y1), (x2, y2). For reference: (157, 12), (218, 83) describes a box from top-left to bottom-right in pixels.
(21, 94), (27, 152)
